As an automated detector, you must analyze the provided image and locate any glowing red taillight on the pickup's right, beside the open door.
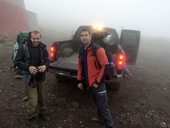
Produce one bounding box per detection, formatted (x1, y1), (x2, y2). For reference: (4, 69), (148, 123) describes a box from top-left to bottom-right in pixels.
(116, 53), (125, 69)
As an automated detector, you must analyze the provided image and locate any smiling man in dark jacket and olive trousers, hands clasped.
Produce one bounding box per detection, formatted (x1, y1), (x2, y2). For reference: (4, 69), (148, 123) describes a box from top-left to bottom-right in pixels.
(15, 31), (50, 128)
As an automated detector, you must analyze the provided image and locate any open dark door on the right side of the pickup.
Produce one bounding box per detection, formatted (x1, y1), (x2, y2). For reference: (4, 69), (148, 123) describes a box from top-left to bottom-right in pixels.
(120, 29), (140, 64)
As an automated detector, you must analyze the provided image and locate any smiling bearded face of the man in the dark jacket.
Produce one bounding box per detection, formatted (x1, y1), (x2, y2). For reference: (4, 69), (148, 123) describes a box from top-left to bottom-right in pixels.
(31, 33), (41, 47)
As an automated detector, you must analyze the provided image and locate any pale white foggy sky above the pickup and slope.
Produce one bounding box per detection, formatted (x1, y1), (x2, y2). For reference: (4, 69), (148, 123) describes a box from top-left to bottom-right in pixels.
(24, 0), (170, 38)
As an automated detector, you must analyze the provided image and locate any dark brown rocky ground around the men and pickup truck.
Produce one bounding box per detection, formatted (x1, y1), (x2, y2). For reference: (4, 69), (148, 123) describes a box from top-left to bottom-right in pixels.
(0, 37), (170, 128)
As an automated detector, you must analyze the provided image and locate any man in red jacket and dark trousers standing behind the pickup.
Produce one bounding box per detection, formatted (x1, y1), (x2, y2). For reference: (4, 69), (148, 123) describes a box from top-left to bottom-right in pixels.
(77, 29), (113, 128)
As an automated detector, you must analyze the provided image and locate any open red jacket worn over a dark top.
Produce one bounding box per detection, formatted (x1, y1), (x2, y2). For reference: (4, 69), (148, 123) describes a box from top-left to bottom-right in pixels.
(77, 47), (108, 86)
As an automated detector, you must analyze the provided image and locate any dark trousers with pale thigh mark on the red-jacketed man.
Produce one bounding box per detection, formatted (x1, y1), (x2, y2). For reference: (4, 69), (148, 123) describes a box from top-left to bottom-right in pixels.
(89, 83), (113, 128)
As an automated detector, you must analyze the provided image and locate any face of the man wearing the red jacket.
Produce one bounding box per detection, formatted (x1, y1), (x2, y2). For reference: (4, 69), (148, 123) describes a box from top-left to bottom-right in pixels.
(80, 31), (91, 45)
